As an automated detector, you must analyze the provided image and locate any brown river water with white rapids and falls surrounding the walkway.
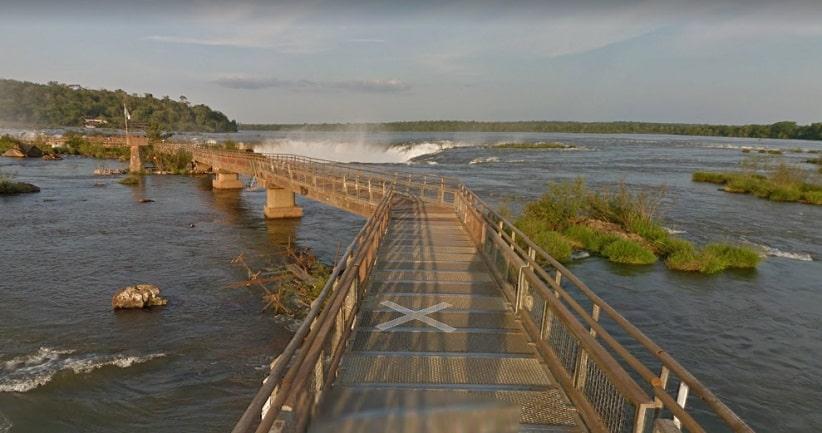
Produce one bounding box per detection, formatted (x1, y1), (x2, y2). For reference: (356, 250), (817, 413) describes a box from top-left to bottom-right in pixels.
(0, 133), (822, 433)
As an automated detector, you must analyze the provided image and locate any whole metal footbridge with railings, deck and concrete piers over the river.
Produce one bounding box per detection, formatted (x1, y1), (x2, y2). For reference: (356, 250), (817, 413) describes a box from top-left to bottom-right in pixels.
(158, 147), (753, 433)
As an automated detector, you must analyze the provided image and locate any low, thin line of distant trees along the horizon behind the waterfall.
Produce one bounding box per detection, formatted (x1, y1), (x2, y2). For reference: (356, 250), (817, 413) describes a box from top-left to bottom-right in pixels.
(240, 120), (822, 140)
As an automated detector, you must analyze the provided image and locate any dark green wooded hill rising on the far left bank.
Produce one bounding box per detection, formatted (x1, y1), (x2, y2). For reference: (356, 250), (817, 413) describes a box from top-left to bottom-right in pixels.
(0, 79), (237, 132)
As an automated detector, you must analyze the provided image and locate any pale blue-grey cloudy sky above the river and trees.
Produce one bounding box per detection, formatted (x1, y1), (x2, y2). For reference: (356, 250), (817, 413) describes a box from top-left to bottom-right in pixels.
(0, 0), (822, 124)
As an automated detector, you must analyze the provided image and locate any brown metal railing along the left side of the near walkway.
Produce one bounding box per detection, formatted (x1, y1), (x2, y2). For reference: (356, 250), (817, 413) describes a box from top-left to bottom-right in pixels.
(232, 192), (393, 433)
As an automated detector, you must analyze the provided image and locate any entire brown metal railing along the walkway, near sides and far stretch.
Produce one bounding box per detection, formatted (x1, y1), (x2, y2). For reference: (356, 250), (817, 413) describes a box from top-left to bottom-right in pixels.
(180, 148), (753, 433)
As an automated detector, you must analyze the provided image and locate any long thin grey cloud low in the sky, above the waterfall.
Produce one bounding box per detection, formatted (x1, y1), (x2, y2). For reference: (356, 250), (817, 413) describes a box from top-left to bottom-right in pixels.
(214, 77), (411, 93)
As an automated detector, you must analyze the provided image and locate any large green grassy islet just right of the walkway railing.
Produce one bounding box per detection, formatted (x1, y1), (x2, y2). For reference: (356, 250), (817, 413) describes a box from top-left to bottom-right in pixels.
(515, 179), (761, 274)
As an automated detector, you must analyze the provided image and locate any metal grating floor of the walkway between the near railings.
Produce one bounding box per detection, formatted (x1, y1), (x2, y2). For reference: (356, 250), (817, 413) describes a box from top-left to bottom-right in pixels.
(312, 198), (584, 433)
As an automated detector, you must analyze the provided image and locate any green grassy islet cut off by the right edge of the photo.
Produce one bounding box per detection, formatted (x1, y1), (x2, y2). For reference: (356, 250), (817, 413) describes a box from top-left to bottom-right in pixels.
(691, 160), (822, 205)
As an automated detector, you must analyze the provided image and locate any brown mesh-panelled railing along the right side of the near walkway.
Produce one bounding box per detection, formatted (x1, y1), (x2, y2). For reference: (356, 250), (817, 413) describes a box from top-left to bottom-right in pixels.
(456, 186), (753, 433)
